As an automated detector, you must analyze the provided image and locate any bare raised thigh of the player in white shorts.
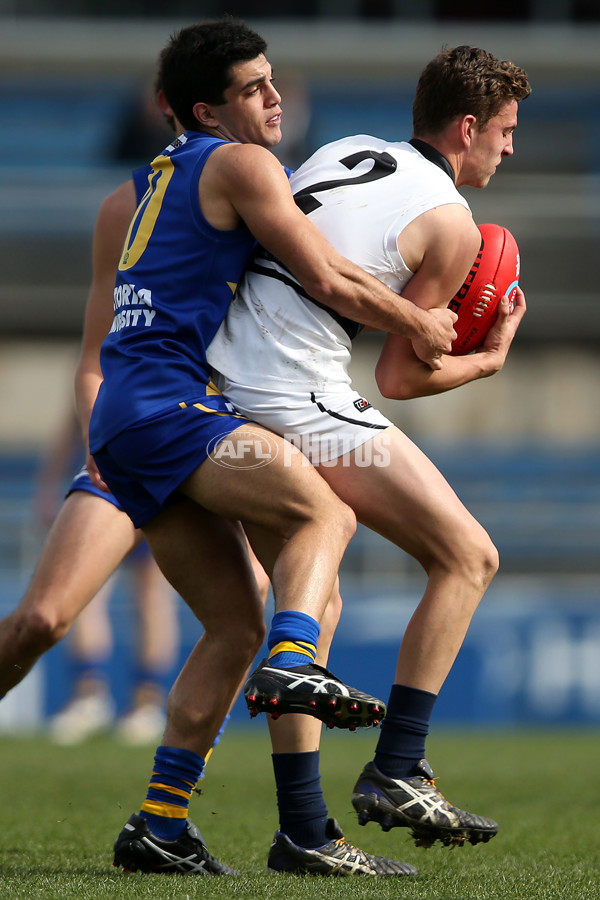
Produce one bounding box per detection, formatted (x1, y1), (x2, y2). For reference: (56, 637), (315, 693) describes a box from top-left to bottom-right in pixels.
(318, 426), (489, 562)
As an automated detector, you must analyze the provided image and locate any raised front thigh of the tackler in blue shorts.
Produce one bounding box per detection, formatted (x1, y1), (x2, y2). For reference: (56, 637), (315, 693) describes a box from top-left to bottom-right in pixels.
(180, 424), (351, 537)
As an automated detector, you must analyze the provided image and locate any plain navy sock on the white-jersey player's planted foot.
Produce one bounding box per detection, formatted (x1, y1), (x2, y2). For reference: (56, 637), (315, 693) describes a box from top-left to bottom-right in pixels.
(272, 750), (329, 849)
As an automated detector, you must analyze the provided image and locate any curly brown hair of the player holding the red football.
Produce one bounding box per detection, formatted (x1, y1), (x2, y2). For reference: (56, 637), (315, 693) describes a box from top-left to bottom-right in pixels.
(413, 45), (531, 137)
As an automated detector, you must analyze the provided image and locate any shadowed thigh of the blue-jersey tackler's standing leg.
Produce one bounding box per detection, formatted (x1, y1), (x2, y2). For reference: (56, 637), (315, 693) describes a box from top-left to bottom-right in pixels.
(143, 499), (264, 631)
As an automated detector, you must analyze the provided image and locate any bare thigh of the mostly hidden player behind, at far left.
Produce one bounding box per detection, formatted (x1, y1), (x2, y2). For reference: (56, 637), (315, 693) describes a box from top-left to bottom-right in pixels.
(22, 491), (140, 619)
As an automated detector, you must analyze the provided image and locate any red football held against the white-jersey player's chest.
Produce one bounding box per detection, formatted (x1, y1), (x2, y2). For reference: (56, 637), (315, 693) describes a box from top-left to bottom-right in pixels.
(448, 225), (521, 356)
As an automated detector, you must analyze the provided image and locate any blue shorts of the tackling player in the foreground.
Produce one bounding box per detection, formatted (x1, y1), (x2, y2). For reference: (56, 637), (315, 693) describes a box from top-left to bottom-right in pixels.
(89, 394), (249, 528)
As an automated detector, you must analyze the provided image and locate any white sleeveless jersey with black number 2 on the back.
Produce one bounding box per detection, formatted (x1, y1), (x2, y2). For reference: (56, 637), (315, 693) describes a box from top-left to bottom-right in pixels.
(207, 135), (469, 403)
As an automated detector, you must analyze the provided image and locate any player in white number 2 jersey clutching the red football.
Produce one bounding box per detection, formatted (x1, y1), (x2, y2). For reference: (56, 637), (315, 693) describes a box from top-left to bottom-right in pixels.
(208, 46), (530, 846)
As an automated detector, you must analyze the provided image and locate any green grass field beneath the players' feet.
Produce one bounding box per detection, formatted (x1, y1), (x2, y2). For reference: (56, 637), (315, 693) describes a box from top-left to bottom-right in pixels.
(0, 721), (600, 900)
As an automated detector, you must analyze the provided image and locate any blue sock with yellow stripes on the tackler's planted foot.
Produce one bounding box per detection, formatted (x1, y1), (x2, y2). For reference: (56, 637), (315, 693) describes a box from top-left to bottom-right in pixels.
(140, 746), (204, 841)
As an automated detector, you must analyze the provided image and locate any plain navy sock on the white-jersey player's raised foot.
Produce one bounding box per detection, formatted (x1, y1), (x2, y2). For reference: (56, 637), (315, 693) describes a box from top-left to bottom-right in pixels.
(374, 684), (437, 778)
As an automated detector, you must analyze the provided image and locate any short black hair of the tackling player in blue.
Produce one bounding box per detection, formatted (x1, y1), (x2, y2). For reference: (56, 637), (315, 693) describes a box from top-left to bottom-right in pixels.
(156, 16), (267, 131)
